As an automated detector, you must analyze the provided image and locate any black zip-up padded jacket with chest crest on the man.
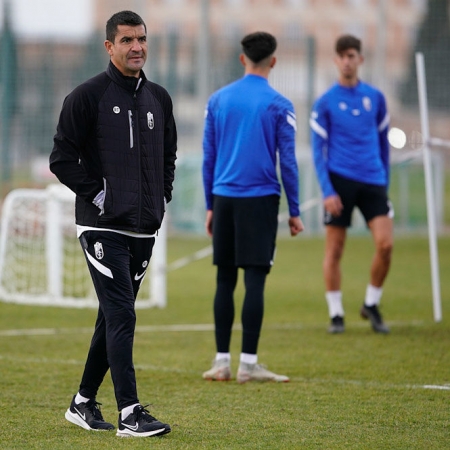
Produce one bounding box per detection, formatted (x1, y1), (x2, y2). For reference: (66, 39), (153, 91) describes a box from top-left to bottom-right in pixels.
(50, 62), (177, 234)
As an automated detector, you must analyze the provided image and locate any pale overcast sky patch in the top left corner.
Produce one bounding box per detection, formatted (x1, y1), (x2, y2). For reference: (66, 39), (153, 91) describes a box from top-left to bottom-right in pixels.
(0, 0), (93, 40)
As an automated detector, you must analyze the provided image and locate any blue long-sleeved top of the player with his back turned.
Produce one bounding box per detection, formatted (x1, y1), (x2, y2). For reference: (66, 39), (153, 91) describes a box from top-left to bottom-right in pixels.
(203, 75), (300, 217)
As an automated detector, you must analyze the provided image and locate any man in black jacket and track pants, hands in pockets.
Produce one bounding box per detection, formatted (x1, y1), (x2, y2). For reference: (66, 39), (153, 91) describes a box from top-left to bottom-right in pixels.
(50, 11), (177, 437)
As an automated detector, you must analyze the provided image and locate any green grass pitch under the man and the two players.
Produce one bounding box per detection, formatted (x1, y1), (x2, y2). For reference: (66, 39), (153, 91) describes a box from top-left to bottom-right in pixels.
(0, 236), (450, 450)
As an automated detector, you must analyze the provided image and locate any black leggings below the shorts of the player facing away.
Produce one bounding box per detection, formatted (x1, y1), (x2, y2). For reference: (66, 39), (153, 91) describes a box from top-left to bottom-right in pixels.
(214, 266), (268, 355)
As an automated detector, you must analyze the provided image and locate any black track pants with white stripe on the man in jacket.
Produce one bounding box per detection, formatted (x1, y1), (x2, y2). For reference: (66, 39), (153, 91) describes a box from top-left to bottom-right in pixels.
(79, 230), (155, 411)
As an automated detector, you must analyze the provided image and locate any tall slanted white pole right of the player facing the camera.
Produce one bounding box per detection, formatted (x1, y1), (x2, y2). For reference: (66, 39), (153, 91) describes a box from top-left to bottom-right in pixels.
(416, 52), (442, 322)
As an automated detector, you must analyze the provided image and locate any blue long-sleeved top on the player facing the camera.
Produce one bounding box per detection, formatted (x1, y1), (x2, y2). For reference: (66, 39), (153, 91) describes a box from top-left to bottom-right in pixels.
(309, 81), (389, 198)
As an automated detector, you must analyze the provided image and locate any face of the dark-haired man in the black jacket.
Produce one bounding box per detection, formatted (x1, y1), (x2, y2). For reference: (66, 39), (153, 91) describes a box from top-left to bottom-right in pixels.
(105, 25), (147, 77)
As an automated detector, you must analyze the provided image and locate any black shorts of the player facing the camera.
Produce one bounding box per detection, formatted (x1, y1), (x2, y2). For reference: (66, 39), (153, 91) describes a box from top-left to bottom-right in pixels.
(323, 172), (394, 228)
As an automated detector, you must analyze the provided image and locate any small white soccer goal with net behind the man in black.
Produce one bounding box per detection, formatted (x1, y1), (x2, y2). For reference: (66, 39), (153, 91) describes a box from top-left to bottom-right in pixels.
(0, 184), (166, 308)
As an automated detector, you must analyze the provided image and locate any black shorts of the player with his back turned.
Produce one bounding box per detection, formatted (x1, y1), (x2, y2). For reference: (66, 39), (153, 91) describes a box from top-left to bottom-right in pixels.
(213, 195), (280, 272)
